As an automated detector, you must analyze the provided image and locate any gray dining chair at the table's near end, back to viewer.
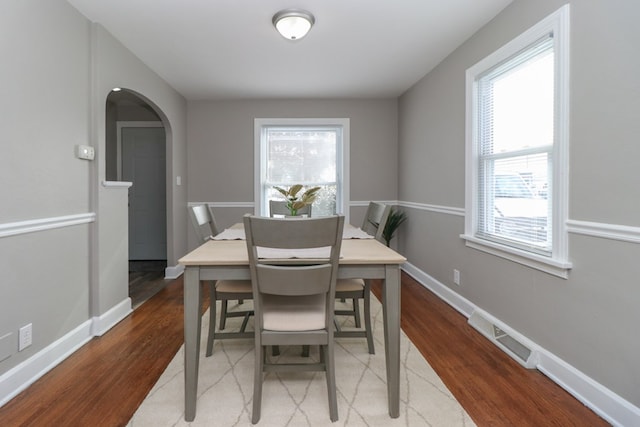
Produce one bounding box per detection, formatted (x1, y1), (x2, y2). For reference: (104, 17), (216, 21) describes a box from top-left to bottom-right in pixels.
(244, 215), (344, 424)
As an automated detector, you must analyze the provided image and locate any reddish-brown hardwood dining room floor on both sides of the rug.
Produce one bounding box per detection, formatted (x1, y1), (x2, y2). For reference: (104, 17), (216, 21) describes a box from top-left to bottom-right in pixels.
(0, 273), (608, 427)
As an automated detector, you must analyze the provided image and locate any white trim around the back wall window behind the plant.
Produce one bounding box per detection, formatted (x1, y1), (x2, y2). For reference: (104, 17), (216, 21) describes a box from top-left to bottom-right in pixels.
(253, 118), (350, 223)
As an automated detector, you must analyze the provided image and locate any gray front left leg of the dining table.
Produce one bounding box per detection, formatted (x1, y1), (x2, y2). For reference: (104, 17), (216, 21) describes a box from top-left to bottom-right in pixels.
(184, 267), (202, 421)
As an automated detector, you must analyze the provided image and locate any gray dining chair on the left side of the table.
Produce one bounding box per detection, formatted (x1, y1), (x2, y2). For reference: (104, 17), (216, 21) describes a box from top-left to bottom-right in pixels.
(189, 204), (253, 356)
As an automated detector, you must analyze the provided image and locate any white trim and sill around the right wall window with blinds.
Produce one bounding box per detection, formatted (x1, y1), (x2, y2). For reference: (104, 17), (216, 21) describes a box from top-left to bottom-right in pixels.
(460, 4), (572, 279)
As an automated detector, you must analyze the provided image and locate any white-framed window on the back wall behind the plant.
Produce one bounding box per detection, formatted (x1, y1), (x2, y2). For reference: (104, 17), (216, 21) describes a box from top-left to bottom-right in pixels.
(255, 119), (349, 221)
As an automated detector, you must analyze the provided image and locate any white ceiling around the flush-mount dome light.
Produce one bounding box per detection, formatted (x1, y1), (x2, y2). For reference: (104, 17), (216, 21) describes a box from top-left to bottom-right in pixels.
(67, 0), (512, 100)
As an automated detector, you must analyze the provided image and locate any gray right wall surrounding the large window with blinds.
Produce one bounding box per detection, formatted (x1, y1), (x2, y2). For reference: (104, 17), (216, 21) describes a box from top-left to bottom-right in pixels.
(399, 0), (640, 406)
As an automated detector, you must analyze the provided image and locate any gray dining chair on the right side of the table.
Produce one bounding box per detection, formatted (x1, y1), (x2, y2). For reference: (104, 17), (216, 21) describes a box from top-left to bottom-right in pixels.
(335, 202), (391, 354)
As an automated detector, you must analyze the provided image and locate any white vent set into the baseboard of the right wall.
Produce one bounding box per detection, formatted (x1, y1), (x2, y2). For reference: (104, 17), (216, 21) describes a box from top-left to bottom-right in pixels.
(469, 310), (537, 369)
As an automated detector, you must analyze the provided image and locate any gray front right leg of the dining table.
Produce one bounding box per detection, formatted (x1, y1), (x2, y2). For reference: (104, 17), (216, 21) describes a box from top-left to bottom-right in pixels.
(382, 265), (400, 418)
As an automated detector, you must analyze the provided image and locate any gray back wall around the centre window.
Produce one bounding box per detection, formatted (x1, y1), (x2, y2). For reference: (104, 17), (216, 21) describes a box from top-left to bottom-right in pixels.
(188, 99), (398, 247)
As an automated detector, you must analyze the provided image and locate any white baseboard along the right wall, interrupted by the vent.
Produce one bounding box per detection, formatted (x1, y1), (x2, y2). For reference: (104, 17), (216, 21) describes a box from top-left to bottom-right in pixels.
(402, 262), (640, 427)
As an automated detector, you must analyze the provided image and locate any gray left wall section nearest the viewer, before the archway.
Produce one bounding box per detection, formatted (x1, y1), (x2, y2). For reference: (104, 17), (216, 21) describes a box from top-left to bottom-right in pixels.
(0, 1), (92, 374)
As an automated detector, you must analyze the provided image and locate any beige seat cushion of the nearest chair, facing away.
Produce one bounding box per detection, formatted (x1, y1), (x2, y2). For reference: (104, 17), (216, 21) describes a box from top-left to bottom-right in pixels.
(262, 294), (326, 331)
